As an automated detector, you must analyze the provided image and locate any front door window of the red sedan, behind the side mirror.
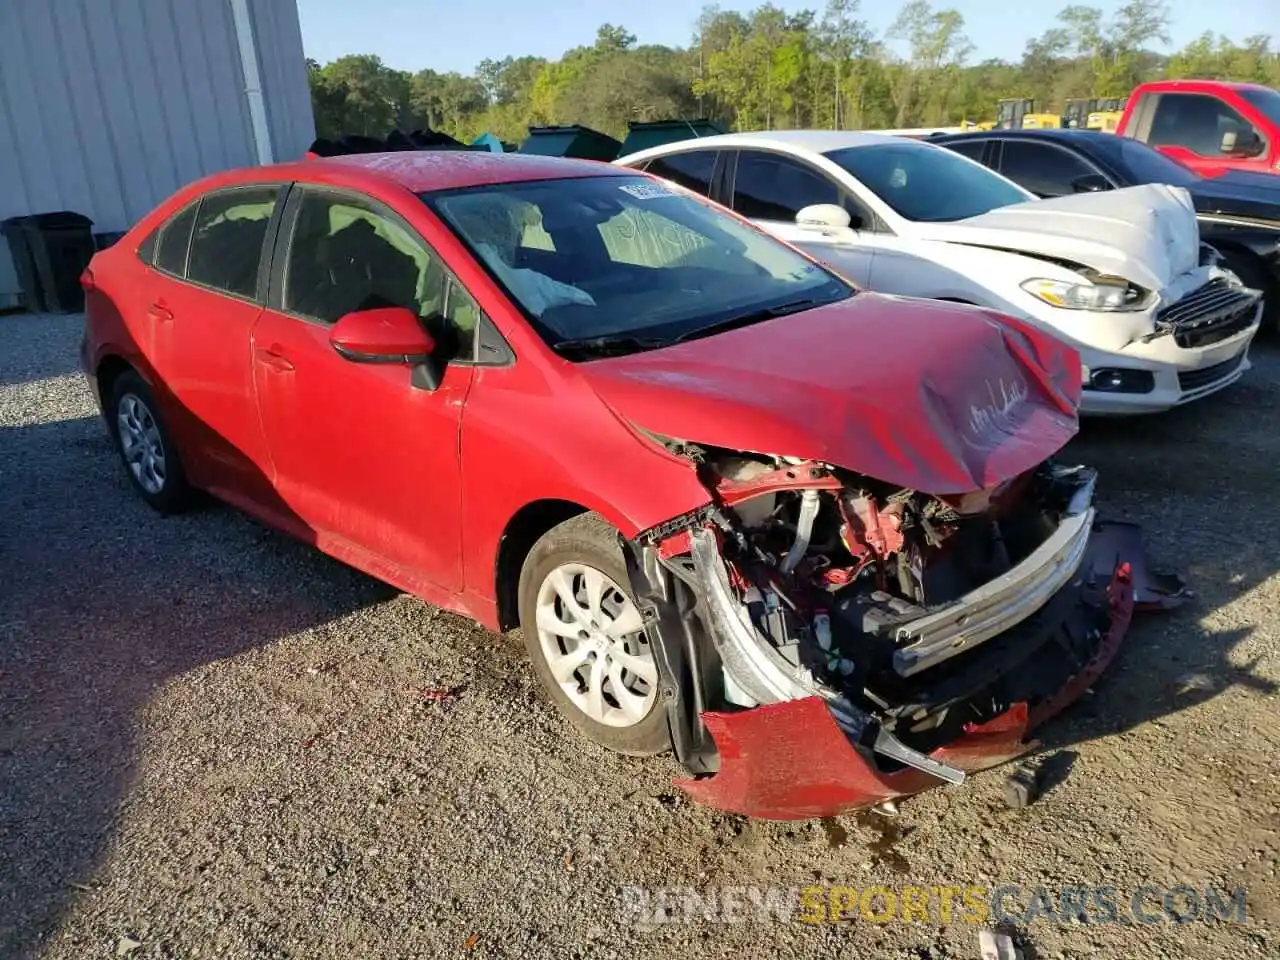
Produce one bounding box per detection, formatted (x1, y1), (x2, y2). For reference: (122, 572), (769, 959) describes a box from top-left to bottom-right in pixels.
(283, 191), (480, 358)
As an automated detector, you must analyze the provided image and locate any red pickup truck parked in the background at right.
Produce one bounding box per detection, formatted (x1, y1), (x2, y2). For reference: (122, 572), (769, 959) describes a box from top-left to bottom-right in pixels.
(1116, 79), (1280, 177)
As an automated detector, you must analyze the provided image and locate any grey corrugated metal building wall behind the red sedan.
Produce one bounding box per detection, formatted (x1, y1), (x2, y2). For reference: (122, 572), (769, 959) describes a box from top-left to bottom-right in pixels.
(0, 0), (315, 297)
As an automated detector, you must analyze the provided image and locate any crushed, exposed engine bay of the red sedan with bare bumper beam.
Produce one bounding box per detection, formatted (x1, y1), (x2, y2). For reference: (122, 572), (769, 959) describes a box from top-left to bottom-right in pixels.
(632, 444), (1180, 808)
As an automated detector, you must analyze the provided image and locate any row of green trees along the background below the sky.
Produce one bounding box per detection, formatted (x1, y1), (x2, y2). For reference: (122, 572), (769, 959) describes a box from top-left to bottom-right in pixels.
(307, 0), (1280, 141)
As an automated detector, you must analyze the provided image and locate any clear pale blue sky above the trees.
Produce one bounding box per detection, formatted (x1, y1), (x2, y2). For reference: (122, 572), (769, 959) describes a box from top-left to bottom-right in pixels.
(297, 0), (1280, 73)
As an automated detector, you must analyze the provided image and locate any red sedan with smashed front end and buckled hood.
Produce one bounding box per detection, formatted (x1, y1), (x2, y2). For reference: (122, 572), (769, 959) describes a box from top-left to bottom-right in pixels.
(82, 151), (1170, 818)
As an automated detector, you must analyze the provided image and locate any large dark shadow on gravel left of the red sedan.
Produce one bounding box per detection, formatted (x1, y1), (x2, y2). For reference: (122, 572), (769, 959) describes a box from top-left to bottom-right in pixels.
(0, 417), (389, 957)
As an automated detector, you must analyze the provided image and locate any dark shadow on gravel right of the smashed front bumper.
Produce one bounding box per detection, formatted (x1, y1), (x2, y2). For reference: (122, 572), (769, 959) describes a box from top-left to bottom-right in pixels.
(1041, 343), (1280, 748)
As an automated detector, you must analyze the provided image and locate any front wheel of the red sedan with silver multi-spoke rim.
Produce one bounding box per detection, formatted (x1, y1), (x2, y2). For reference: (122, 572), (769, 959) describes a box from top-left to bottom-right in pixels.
(520, 513), (671, 756)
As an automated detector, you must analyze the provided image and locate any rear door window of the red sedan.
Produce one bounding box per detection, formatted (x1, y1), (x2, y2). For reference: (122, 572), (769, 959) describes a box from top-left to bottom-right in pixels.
(187, 186), (279, 298)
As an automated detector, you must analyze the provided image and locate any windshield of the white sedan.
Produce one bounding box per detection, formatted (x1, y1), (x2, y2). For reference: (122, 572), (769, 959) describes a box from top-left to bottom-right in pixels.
(826, 140), (1036, 221)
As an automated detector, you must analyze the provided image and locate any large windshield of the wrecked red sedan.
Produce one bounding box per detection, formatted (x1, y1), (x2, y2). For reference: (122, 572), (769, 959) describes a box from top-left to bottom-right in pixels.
(422, 175), (852, 349)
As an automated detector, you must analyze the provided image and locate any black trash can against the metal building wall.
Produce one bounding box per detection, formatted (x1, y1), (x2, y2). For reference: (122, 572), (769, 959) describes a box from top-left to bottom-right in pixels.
(4, 210), (95, 314)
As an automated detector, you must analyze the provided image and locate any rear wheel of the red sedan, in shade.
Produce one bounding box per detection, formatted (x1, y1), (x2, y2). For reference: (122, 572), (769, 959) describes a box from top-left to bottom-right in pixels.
(108, 370), (191, 513)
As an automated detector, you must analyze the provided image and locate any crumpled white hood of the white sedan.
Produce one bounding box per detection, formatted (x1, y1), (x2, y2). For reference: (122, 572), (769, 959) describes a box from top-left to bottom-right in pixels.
(915, 183), (1199, 291)
